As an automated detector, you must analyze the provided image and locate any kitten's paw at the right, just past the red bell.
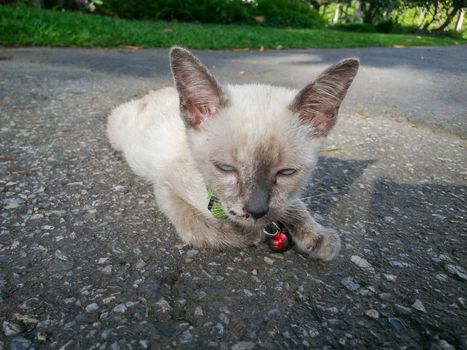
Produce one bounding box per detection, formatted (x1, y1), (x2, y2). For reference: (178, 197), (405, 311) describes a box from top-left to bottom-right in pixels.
(294, 227), (341, 261)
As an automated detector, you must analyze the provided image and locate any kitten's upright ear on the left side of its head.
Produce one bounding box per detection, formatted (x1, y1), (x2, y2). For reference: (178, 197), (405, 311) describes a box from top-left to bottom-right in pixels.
(170, 47), (226, 128)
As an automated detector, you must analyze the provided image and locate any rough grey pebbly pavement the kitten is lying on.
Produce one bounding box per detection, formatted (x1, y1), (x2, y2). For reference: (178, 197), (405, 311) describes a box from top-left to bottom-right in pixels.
(0, 46), (467, 350)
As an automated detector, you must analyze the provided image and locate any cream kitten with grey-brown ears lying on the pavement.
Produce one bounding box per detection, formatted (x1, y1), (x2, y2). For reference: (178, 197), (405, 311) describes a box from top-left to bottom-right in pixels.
(107, 47), (359, 261)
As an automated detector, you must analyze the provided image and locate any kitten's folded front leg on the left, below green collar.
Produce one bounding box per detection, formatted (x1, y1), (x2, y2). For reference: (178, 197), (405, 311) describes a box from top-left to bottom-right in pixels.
(156, 188), (261, 248)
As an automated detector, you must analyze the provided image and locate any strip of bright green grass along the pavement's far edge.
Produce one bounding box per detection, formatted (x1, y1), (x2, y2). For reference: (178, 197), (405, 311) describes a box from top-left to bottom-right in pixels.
(0, 6), (467, 49)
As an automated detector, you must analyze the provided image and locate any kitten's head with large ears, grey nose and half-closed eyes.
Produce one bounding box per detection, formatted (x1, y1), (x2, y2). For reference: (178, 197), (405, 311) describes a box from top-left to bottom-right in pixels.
(170, 47), (359, 226)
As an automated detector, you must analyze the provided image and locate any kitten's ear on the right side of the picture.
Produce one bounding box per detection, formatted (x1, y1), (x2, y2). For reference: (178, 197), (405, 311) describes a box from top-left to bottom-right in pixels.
(290, 58), (359, 136)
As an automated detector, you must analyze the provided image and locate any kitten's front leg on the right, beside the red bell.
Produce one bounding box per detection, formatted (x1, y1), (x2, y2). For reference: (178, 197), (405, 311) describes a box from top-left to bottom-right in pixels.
(284, 200), (341, 261)
